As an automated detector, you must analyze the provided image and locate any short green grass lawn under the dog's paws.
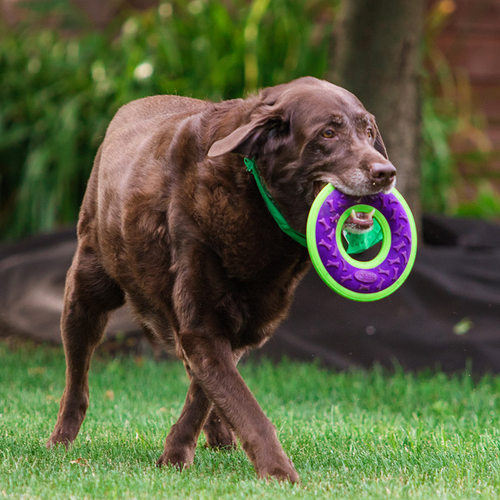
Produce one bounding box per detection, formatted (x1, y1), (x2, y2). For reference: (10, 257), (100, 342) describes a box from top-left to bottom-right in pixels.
(0, 343), (500, 499)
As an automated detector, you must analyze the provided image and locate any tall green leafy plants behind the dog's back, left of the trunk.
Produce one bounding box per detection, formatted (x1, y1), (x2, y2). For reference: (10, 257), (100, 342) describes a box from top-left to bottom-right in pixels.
(0, 0), (333, 238)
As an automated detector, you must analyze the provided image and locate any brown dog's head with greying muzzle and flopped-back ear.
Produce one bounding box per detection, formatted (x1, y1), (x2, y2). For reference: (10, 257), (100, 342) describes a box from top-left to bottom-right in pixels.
(208, 77), (396, 232)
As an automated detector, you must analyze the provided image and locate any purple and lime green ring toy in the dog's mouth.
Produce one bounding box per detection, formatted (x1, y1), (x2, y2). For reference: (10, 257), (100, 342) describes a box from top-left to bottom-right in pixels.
(306, 184), (417, 302)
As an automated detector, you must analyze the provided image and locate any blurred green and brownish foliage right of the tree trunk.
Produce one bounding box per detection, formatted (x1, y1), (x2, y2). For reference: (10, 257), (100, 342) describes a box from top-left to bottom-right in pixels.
(421, 0), (494, 217)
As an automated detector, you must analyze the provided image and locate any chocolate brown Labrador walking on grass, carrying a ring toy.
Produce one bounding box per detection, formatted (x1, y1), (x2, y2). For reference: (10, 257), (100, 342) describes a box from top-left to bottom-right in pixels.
(47, 77), (395, 482)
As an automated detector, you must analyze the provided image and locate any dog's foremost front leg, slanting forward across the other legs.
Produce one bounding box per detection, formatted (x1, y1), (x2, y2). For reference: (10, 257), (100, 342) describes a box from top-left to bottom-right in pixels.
(179, 330), (299, 482)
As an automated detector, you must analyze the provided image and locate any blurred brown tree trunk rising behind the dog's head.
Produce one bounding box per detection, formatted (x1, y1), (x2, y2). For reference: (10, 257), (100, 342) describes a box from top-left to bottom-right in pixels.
(332, 0), (424, 225)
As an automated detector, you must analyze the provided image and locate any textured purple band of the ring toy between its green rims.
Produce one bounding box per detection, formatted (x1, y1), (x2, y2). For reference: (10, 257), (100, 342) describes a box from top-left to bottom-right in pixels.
(316, 189), (412, 293)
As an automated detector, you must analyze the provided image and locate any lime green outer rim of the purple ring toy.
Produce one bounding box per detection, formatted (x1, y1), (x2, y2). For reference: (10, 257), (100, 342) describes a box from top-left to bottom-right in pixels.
(306, 184), (417, 302)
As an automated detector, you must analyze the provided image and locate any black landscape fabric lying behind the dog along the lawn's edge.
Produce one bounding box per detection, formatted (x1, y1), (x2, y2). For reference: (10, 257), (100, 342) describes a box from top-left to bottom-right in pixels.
(0, 216), (500, 373)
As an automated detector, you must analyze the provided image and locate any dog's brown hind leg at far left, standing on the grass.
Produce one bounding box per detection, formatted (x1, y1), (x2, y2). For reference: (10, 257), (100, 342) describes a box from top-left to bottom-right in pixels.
(47, 245), (124, 447)
